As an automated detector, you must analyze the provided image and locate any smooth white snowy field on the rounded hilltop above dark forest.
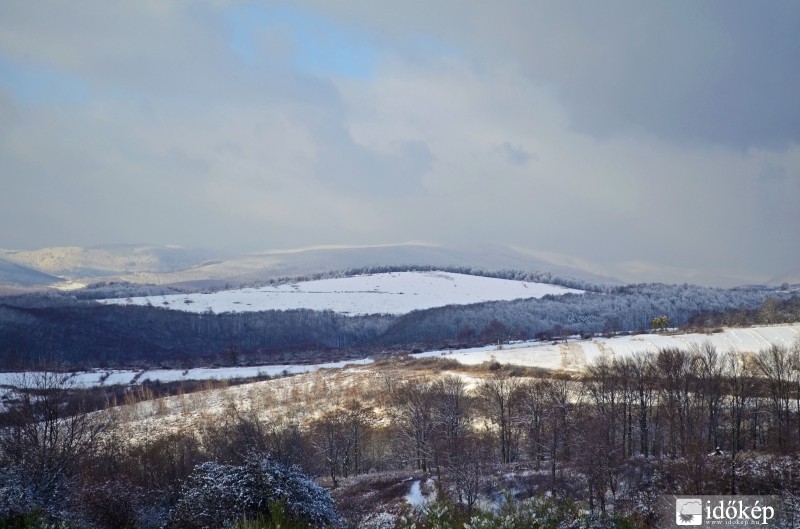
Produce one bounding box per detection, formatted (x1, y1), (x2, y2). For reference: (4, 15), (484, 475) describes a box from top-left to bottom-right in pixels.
(101, 272), (582, 315)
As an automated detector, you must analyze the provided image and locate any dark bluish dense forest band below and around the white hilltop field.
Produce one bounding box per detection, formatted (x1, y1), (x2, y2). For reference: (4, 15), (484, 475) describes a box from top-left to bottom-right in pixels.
(0, 268), (793, 369)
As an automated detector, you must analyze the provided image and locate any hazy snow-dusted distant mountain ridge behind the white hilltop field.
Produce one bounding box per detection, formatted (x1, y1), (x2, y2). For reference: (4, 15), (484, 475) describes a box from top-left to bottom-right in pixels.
(0, 243), (622, 289)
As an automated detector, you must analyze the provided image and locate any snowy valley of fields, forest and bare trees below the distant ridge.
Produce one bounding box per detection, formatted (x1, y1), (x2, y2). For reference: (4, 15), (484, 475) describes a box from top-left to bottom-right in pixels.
(0, 245), (800, 529)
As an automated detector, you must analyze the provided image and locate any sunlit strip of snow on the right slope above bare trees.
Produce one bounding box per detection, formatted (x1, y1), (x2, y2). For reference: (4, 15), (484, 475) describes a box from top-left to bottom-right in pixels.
(414, 323), (800, 371)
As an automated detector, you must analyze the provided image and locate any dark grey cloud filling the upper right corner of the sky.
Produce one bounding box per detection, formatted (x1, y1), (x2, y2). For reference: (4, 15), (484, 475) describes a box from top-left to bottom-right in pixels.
(305, 0), (800, 148)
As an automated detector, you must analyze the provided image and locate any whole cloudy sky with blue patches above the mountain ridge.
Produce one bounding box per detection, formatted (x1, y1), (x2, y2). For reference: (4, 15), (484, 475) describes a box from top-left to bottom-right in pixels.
(0, 0), (800, 283)
